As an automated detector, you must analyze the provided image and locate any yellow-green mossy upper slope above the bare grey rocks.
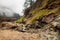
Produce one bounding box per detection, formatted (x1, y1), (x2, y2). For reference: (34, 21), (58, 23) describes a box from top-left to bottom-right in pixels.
(17, 0), (60, 25)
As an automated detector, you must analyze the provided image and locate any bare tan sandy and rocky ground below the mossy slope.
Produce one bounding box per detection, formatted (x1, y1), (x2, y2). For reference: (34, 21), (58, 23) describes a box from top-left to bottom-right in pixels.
(0, 14), (60, 40)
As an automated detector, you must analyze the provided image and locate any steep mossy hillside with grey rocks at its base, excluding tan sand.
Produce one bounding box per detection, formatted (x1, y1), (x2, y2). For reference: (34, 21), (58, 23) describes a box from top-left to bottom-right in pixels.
(15, 0), (60, 40)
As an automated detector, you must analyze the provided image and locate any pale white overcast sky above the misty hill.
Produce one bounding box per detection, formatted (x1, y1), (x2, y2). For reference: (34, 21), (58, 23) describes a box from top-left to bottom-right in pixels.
(0, 0), (25, 15)
